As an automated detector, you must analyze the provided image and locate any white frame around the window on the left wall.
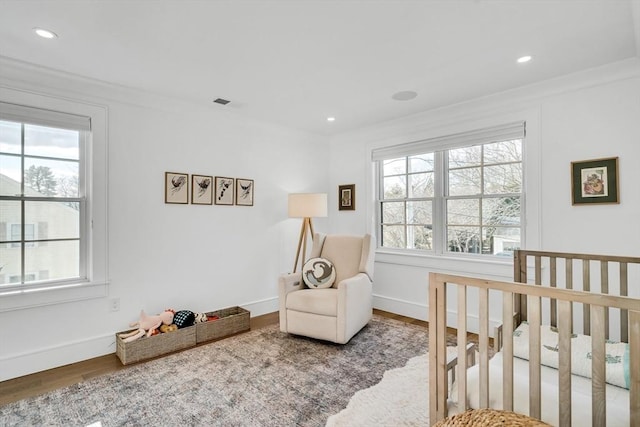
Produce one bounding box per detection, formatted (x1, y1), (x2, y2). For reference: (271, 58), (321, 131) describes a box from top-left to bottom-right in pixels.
(0, 87), (108, 312)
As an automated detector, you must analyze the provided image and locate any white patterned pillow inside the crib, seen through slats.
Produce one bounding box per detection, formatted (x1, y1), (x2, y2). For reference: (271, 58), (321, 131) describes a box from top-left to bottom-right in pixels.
(513, 322), (631, 389)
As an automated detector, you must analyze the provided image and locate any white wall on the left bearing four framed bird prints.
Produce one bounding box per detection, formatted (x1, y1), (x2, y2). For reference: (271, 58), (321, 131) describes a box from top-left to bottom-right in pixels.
(0, 57), (328, 380)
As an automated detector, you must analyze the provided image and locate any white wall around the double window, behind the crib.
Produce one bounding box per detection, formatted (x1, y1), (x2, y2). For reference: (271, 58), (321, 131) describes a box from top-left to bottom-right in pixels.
(330, 59), (640, 330)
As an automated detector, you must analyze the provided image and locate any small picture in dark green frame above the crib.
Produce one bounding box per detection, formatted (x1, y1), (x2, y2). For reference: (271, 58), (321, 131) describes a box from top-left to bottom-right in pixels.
(571, 157), (620, 205)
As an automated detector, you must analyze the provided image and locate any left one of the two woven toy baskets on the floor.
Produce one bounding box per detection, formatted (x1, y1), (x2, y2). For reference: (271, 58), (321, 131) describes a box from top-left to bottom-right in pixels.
(116, 326), (196, 365)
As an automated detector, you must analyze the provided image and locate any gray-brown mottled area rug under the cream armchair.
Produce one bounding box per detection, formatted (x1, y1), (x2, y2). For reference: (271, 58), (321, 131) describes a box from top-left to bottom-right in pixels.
(0, 316), (444, 427)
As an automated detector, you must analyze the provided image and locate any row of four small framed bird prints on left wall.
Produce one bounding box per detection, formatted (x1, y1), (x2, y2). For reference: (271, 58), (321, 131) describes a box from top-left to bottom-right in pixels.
(164, 172), (254, 206)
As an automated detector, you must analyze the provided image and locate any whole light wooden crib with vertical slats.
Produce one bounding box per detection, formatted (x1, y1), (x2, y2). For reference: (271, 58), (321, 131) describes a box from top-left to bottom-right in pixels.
(429, 251), (640, 426)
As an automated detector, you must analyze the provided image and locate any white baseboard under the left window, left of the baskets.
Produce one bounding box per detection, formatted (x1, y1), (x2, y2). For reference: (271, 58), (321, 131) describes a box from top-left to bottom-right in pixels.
(0, 333), (116, 381)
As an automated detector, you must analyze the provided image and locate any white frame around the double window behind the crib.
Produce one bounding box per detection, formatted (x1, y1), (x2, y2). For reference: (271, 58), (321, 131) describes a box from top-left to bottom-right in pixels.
(371, 120), (527, 261)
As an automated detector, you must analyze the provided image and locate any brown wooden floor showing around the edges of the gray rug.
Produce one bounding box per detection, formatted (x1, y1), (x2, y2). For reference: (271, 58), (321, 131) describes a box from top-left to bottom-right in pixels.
(0, 310), (436, 406)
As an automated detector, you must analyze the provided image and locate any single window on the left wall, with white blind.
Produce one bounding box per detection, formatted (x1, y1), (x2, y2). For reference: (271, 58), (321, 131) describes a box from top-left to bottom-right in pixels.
(0, 103), (90, 289)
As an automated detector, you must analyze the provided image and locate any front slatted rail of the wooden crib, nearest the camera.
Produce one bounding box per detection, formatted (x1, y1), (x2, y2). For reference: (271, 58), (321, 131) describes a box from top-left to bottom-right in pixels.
(429, 273), (640, 426)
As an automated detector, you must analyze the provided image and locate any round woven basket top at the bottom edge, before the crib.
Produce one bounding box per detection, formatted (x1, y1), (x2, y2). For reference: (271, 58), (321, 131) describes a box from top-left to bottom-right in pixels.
(434, 409), (549, 427)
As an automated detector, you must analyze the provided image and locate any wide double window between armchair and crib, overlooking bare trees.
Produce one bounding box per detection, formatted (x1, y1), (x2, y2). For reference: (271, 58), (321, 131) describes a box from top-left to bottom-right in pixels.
(373, 122), (524, 256)
